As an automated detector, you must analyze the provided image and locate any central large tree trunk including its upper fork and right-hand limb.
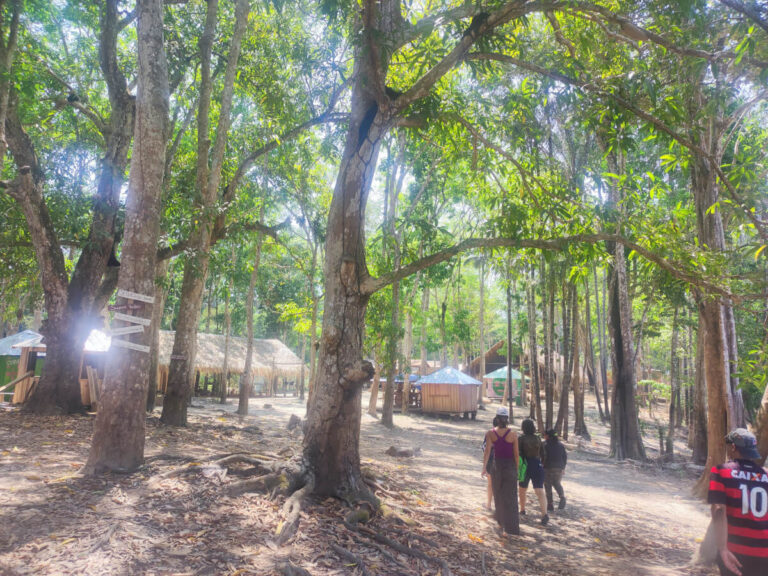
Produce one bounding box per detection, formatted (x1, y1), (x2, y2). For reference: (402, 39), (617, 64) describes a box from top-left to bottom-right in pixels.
(304, 0), (540, 501)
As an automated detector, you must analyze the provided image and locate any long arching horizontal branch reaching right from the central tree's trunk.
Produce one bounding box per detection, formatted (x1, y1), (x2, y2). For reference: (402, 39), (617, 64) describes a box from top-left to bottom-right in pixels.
(361, 233), (739, 301)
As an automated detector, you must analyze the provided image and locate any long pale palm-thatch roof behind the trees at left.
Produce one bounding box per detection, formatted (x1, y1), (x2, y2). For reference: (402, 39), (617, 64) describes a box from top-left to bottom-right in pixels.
(159, 330), (308, 379)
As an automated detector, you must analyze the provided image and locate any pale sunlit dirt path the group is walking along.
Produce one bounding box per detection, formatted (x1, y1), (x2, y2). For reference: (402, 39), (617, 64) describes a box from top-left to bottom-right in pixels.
(356, 394), (709, 575)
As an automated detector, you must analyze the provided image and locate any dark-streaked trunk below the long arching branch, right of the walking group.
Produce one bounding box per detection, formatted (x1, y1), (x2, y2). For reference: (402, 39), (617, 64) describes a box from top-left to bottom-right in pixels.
(608, 244), (645, 460)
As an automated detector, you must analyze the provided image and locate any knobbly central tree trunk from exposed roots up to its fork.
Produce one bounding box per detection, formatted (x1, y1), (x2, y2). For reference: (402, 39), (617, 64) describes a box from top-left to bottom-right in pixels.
(304, 72), (385, 501)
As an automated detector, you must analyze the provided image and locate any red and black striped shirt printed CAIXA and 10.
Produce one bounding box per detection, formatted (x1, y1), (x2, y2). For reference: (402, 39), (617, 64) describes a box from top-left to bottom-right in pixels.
(708, 460), (768, 559)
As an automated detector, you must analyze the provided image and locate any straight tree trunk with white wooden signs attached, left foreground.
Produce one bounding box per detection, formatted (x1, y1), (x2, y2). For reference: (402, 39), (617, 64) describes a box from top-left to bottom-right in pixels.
(86, 0), (168, 473)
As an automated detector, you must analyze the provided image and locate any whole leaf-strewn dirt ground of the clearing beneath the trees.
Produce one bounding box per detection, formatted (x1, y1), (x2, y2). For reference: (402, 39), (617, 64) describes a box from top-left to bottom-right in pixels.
(0, 394), (713, 576)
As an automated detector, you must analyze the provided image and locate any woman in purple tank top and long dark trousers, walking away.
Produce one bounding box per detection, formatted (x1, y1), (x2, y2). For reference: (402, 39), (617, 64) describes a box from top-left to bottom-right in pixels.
(480, 406), (520, 537)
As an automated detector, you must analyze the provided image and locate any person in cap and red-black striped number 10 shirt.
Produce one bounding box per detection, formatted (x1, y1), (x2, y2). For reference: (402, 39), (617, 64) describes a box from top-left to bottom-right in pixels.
(708, 428), (768, 576)
